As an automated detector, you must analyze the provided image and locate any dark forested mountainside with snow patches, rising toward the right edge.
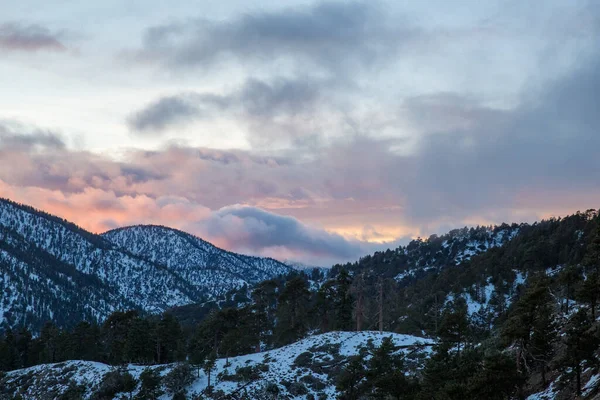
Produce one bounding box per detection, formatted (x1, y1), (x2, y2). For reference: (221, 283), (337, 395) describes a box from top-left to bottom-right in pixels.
(330, 210), (598, 333)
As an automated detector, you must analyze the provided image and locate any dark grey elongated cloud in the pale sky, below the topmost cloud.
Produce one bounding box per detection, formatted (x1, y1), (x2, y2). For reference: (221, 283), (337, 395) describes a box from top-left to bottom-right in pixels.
(127, 78), (328, 144)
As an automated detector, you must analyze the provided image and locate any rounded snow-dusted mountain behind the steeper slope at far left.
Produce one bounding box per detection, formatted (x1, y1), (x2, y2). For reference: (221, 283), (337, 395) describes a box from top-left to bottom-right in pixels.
(102, 225), (292, 296)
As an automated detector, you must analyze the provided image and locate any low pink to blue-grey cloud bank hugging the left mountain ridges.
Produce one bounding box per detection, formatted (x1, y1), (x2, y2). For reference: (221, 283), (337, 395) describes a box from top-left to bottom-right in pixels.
(0, 180), (376, 266)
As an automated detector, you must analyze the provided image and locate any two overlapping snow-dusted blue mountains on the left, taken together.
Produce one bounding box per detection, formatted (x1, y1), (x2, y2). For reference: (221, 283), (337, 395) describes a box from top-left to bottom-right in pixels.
(0, 199), (291, 331)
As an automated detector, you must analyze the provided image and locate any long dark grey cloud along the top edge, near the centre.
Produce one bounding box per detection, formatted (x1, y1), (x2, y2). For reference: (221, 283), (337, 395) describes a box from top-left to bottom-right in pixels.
(140, 2), (415, 71)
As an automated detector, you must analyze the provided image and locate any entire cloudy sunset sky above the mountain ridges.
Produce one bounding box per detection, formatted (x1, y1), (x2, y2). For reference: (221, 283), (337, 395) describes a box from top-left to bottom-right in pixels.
(0, 0), (600, 266)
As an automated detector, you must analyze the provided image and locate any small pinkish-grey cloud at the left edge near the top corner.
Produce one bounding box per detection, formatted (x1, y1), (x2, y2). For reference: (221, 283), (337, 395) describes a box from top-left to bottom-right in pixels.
(0, 22), (66, 52)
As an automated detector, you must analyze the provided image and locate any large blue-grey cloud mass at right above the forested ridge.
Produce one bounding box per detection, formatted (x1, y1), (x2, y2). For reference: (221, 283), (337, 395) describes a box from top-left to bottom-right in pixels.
(402, 36), (600, 221)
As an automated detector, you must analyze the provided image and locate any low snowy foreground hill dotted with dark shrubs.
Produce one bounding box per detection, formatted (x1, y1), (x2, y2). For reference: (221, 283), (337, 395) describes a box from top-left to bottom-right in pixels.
(0, 331), (432, 399)
